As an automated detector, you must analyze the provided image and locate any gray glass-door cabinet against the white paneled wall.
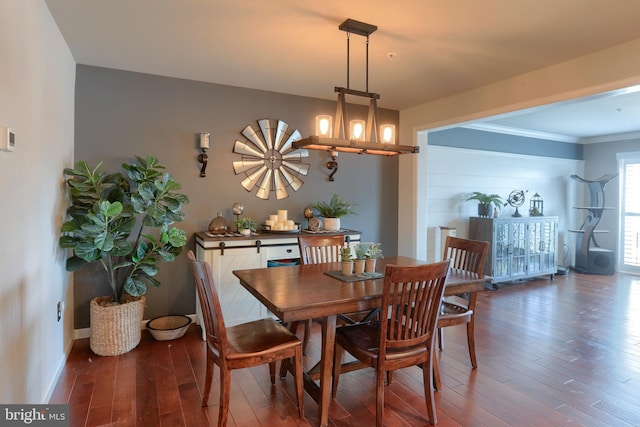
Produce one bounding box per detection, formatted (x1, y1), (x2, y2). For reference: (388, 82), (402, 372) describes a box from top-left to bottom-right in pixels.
(469, 216), (558, 284)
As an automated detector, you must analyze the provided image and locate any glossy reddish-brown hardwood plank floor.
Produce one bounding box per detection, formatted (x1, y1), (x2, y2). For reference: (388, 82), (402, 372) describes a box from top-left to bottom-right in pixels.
(51, 272), (640, 427)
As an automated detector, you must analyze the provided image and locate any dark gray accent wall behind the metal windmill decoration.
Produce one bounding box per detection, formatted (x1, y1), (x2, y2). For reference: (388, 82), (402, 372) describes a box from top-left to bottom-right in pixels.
(74, 65), (399, 328)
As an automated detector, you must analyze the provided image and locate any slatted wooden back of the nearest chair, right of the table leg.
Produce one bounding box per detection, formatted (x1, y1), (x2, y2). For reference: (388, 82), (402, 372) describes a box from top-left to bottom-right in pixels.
(380, 260), (450, 354)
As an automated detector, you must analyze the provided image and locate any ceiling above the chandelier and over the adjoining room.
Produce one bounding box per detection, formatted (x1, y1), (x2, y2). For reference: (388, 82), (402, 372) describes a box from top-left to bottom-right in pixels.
(45, 0), (640, 141)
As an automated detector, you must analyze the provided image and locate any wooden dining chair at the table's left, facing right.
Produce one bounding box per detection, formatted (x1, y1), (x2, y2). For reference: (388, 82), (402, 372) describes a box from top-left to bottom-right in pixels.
(187, 251), (304, 426)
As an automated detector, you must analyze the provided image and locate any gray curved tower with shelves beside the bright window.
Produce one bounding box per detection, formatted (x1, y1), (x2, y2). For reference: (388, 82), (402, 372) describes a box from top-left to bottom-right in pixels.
(569, 174), (618, 275)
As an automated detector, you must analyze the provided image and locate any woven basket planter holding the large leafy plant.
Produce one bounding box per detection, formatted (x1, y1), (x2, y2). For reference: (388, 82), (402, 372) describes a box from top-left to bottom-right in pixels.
(89, 297), (147, 356)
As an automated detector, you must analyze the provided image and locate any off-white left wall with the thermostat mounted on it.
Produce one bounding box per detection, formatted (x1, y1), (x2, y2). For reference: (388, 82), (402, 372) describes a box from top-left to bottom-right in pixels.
(0, 0), (75, 404)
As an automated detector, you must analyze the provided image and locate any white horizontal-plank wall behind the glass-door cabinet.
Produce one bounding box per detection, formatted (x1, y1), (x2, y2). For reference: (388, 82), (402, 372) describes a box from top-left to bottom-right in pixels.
(426, 146), (584, 263)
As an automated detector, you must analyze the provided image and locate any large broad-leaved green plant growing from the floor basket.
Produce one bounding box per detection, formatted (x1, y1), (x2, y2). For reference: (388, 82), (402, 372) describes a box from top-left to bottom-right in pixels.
(58, 156), (189, 302)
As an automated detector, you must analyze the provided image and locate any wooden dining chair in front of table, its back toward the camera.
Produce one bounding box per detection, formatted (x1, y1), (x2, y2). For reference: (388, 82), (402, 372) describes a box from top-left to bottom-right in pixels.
(333, 261), (450, 427)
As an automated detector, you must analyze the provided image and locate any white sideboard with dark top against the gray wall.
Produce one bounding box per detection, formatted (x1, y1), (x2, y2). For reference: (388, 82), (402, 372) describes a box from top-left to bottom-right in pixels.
(195, 230), (360, 339)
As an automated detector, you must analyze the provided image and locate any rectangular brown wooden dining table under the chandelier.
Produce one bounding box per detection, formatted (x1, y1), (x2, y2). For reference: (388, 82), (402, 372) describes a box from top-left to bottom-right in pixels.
(233, 257), (491, 426)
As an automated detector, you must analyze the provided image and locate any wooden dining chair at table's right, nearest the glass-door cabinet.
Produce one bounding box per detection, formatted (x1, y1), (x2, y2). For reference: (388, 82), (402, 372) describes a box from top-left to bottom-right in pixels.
(434, 236), (489, 390)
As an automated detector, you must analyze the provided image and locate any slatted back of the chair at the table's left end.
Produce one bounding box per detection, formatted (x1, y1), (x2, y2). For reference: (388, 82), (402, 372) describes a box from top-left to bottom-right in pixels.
(187, 251), (229, 363)
